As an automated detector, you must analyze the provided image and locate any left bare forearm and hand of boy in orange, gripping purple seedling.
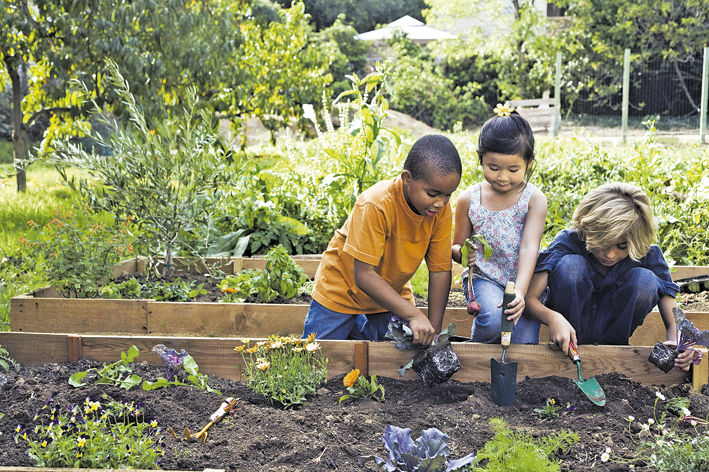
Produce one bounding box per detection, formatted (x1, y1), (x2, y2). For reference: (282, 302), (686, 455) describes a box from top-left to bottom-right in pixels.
(354, 259), (434, 346)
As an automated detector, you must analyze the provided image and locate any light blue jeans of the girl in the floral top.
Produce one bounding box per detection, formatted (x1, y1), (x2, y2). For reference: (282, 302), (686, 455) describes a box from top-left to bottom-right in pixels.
(463, 278), (541, 344)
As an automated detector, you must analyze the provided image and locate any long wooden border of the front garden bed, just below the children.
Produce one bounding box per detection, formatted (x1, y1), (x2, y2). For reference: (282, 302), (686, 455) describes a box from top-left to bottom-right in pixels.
(0, 332), (696, 388)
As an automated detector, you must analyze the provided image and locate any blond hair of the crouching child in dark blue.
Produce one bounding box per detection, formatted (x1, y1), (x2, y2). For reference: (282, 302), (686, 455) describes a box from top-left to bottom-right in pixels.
(571, 182), (655, 261)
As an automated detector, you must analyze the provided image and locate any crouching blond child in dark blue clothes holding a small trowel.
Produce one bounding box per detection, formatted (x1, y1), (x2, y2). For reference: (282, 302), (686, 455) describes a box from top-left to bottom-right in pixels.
(526, 182), (691, 370)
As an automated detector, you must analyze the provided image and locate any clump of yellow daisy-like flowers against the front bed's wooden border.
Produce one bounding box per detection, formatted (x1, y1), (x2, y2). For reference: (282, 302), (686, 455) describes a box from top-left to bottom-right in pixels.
(234, 333), (327, 408)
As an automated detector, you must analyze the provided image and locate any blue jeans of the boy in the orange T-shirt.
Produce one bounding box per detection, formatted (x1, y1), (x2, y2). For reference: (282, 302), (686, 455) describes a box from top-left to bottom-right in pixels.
(303, 300), (392, 341)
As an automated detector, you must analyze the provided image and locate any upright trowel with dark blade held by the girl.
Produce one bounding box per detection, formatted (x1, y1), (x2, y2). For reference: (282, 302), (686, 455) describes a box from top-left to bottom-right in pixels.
(490, 282), (517, 406)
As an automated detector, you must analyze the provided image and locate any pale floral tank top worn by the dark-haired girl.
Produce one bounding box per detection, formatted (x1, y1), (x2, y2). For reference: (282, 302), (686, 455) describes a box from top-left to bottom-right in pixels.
(464, 183), (537, 287)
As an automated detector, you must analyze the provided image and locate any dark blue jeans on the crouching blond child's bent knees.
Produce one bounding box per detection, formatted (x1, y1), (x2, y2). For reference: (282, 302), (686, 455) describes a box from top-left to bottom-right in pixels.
(546, 254), (664, 345)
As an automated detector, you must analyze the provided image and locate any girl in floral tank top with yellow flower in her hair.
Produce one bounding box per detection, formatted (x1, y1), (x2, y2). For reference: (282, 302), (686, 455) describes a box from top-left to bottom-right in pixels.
(452, 105), (547, 344)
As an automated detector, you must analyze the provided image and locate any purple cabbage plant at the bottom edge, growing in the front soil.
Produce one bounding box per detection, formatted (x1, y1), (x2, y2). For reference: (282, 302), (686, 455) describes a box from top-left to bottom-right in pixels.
(359, 425), (475, 472)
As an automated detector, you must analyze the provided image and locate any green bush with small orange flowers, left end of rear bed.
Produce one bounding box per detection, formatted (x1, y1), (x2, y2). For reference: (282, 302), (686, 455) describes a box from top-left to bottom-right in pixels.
(21, 209), (133, 298)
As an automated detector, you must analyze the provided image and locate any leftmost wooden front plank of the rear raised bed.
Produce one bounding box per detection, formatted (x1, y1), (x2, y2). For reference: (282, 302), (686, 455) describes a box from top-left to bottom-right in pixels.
(10, 297), (148, 334)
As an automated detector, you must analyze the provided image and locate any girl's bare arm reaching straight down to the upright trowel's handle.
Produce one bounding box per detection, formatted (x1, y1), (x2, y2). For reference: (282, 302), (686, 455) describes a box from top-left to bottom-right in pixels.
(505, 190), (547, 322)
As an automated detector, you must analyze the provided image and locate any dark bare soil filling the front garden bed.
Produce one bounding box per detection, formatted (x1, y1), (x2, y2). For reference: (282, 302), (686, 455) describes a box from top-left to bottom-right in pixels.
(0, 358), (709, 472)
